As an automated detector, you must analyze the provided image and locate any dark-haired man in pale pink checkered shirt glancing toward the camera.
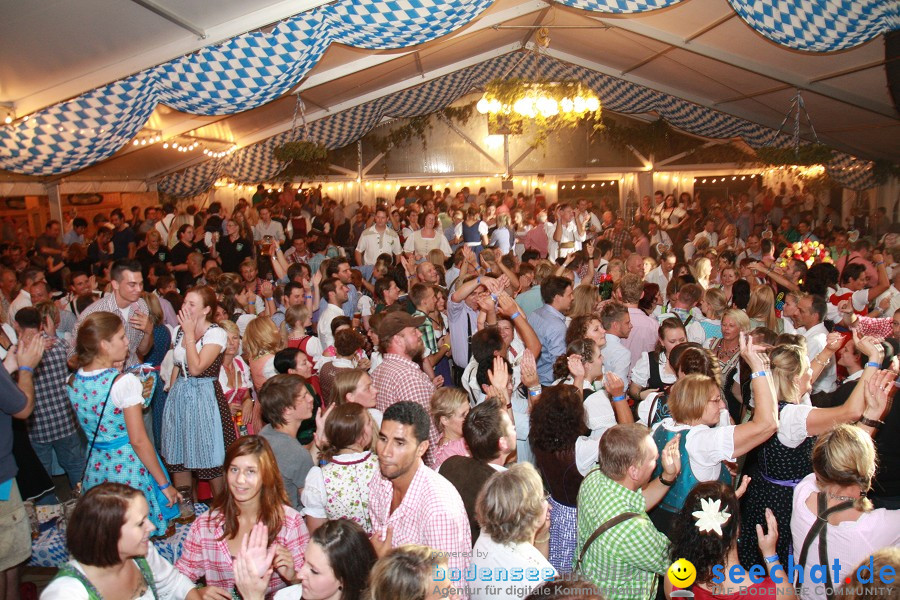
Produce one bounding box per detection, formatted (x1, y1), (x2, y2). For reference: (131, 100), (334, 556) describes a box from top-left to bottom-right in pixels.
(369, 402), (472, 592)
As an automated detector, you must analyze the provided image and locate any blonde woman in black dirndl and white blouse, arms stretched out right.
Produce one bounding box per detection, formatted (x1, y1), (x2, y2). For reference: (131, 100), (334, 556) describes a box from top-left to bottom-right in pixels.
(738, 337), (884, 564)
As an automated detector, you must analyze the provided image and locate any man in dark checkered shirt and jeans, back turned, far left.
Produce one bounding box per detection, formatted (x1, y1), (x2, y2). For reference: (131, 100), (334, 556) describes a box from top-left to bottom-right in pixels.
(15, 306), (85, 487)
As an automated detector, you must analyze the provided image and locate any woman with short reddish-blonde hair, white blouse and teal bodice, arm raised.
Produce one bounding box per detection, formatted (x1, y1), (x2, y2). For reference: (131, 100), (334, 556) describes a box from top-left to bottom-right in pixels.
(650, 335), (778, 534)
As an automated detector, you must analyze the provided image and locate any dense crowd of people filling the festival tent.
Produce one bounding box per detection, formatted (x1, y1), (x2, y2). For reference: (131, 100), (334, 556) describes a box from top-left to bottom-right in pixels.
(0, 184), (900, 600)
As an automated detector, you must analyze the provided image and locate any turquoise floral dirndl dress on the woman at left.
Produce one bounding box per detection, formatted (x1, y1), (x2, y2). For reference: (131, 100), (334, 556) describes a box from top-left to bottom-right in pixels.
(67, 369), (178, 535)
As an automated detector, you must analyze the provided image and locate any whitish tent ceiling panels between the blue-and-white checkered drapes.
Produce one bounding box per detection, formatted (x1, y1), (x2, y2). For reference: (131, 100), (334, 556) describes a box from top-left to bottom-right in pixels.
(0, 0), (900, 189)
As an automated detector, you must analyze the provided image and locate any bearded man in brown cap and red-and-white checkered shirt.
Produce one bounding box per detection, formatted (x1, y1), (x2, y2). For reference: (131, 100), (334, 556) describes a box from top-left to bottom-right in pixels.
(372, 311), (443, 467)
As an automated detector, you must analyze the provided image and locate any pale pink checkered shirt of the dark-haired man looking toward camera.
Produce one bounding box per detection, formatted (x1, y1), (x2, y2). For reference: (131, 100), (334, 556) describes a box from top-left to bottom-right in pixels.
(369, 461), (472, 569)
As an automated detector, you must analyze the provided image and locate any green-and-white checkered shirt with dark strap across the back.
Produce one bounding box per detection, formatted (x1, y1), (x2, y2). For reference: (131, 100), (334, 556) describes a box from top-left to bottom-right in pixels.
(575, 469), (669, 600)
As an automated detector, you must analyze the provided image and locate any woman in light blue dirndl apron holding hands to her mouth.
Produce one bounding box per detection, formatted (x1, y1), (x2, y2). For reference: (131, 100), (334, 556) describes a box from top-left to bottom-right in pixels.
(162, 286), (236, 494)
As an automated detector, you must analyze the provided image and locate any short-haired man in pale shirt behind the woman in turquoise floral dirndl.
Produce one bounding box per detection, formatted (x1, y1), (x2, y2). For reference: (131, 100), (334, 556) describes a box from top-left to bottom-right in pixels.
(75, 259), (153, 367)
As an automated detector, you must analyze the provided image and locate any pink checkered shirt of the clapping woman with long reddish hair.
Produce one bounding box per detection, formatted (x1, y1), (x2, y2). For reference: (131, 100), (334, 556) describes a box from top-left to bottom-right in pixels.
(175, 506), (309, 598)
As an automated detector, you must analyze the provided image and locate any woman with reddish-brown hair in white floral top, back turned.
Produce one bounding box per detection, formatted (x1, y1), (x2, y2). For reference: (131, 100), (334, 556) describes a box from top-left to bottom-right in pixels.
(300, 402), (379, 533)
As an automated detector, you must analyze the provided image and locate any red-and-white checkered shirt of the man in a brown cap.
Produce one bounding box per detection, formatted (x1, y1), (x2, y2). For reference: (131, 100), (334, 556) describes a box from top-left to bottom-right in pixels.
(372, 354), (441, 467)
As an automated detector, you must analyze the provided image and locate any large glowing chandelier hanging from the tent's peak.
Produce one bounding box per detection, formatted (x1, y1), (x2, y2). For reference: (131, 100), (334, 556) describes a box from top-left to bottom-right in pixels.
(475, 27), (600, 126)
